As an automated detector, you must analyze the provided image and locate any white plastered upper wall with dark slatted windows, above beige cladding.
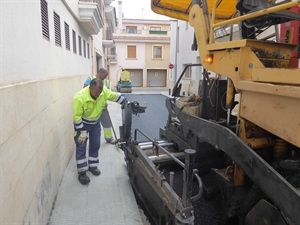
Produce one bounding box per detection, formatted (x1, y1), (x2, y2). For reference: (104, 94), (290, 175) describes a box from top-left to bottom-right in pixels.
(0, 0), (92, 85)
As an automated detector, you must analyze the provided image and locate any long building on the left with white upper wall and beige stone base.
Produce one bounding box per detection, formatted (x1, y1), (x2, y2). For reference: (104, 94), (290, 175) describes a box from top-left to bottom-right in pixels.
(0, 0), (116, 224)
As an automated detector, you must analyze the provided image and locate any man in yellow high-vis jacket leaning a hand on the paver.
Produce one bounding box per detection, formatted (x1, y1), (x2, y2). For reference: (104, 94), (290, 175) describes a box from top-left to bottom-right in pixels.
(72, 78), (126, 184)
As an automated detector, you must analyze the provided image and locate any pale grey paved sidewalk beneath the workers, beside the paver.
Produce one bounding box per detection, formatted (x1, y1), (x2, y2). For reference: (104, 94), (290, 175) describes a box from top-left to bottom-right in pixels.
(48, 102), (144, 225)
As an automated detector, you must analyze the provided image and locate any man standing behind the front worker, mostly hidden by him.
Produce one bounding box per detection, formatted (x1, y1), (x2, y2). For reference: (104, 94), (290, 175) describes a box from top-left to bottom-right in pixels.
(83, 68), (116, 145)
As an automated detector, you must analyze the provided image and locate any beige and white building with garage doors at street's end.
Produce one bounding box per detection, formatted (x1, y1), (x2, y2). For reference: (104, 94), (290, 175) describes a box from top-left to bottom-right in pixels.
(109, 16), (171, 90)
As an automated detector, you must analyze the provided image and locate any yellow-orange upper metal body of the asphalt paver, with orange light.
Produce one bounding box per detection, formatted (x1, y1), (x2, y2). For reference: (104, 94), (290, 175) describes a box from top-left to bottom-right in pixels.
(151, 0), (300, 147)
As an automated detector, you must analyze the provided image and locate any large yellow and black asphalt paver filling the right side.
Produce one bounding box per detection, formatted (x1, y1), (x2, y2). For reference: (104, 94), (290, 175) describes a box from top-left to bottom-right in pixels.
(119, 0), (300, 225)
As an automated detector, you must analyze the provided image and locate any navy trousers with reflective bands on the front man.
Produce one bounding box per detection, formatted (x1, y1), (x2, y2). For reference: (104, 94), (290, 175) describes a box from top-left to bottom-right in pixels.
(74, 123), (101, 173)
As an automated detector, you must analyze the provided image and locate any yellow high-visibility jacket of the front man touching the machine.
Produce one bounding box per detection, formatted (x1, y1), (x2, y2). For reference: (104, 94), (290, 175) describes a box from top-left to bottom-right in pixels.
(72, 86), (125, 130)
